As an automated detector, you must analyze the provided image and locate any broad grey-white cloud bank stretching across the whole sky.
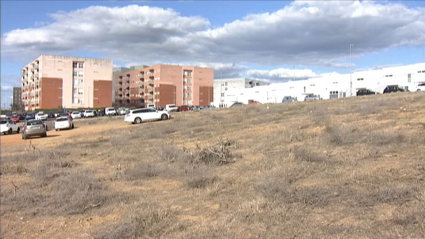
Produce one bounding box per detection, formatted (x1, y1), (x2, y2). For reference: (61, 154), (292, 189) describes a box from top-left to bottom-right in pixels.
(1, 1), (425, 67)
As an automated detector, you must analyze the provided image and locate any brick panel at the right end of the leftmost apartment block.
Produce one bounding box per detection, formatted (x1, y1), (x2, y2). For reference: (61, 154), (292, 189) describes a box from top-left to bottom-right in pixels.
(90, 80), (112, 108)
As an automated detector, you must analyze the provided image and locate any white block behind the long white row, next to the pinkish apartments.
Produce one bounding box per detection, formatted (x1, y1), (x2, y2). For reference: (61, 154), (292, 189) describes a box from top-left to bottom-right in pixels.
(213, 78), (270, 108)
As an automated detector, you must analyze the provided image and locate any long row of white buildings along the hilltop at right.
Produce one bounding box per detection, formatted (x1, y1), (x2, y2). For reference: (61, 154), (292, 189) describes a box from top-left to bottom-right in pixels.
(213, 63), (425, 107)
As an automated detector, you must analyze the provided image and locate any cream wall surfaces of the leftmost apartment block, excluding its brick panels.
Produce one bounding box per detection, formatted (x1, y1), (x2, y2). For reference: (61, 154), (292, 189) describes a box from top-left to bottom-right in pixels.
(22, 55), (112, 109)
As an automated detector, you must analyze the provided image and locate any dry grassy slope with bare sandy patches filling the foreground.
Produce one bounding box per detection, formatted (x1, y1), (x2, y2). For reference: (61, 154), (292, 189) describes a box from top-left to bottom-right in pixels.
(1, 92), (425, 239)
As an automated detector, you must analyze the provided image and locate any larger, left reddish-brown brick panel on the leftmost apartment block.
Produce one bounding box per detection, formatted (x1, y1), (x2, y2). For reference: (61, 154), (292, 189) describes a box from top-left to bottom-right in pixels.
(39, 77), (63, 109)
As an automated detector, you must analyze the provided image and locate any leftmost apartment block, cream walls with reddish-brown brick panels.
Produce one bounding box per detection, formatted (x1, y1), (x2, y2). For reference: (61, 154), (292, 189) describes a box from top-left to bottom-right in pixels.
(21, 55), (112, 110)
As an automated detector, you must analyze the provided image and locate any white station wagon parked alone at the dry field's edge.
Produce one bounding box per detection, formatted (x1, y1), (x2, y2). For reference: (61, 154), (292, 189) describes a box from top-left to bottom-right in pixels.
(124, 108), (170, 124)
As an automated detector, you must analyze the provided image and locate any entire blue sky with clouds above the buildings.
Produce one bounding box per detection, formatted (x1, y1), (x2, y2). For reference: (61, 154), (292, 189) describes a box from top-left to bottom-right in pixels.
(0, 0), (425, 106)
